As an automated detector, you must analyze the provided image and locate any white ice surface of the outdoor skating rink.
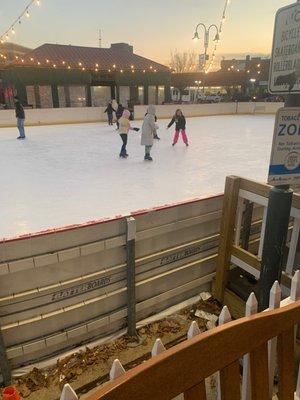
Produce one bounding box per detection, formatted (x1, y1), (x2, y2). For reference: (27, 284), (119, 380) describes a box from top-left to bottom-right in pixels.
(0, 116), (274, 238)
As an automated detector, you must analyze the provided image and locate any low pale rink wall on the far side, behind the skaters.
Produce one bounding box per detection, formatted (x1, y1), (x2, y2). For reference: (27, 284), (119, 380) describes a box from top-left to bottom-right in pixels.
(0, 102), (283, 127)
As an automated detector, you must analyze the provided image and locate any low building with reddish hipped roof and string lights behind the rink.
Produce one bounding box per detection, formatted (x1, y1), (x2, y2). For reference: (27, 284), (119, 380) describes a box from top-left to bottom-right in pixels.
(2, 43), (171, 108)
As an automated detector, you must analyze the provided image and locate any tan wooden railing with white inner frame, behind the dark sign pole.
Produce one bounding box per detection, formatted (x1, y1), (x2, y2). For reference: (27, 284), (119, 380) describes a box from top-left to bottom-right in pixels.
(214, 176), (300, 302)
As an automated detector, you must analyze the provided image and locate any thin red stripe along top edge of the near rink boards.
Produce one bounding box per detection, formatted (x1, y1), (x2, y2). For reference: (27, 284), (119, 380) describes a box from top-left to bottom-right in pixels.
(0, 193), (223, 244)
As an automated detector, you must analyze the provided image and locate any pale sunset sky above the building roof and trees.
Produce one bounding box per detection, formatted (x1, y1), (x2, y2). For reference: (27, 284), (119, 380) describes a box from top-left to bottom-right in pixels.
(0, 0), (292, 63)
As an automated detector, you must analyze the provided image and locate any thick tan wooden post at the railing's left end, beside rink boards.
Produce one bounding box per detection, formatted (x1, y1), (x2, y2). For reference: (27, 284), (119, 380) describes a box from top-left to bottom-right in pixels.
(214, 176), (240, 302)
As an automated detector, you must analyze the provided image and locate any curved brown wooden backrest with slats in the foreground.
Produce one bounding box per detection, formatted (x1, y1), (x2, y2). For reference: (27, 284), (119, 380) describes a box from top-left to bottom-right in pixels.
(71, 301), (300, 400)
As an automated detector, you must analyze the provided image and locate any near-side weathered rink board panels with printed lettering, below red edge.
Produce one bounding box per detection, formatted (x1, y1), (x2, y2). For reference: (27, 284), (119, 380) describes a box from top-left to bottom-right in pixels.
(0, 196), (222, 366)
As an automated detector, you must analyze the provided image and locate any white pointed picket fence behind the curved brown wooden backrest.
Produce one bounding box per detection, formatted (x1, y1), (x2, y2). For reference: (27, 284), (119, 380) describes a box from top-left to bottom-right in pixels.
(60, 270), (300, 400)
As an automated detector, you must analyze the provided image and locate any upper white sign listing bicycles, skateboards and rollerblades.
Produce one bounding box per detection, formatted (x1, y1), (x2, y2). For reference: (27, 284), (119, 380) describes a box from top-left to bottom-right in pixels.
(269, 3), (300, 94)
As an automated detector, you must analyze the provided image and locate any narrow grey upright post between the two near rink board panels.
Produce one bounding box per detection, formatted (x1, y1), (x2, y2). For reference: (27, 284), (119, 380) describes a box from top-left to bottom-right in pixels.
(126, 217), (137, 336)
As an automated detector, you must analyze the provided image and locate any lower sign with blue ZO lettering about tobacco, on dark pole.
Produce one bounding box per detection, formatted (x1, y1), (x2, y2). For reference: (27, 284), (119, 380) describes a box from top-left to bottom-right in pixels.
(268, 107), (300, 186)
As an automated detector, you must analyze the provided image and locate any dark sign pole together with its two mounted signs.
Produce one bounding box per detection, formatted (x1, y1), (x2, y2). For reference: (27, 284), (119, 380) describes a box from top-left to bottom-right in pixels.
(258, 0), (300, 311)
